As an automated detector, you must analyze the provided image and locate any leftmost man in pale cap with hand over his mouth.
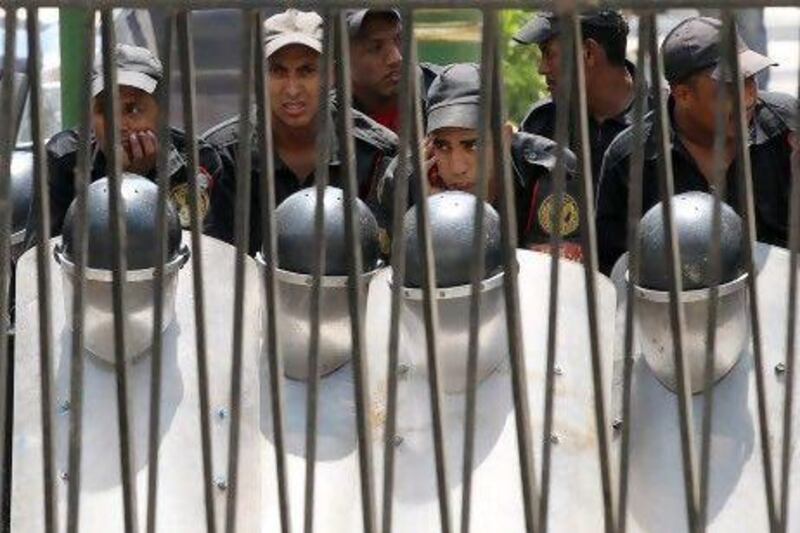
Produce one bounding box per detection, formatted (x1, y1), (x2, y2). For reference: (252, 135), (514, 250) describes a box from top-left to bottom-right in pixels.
(31, 44), (223, 239)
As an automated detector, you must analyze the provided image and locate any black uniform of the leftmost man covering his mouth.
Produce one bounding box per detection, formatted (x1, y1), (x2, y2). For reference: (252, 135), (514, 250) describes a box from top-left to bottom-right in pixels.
(26, 128), (223, 240)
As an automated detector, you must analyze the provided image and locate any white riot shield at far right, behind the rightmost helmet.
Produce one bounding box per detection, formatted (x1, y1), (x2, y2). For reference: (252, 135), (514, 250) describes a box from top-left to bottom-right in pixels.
(612, 243), (800, 533)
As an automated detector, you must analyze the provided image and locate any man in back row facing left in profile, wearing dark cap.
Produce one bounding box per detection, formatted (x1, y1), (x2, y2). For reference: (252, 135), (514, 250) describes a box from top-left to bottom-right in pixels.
(514, 9), (637, 181)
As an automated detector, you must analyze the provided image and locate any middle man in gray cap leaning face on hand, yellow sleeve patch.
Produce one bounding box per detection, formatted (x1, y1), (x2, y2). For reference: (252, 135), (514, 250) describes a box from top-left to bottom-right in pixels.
(378, 63), (582, 260)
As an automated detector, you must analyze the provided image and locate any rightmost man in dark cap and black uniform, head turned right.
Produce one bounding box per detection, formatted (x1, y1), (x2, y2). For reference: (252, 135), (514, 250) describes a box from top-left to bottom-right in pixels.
(597, 17), (797, 273)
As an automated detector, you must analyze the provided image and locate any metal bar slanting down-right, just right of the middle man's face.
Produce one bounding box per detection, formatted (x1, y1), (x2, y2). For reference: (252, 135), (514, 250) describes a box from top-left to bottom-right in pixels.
(484, 8), (538, 532)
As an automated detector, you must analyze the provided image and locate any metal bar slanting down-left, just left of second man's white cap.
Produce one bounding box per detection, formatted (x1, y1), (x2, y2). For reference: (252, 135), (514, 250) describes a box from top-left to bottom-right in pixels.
(225, 9), (255, 533)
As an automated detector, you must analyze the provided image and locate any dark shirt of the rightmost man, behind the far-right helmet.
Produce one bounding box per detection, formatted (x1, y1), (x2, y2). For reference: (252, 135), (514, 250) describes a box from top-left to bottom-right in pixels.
(597, 92), (797, 274)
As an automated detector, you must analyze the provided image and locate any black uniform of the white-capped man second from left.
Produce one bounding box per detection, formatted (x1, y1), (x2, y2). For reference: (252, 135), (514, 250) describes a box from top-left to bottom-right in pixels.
(204, 106), (397, 254)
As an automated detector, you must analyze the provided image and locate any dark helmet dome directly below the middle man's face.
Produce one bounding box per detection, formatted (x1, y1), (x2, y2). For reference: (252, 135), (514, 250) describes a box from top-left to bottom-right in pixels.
(403, 191), (503, 288)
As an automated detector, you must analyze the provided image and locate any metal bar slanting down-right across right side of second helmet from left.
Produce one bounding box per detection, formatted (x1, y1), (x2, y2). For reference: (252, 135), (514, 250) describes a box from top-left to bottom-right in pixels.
(334, 11), (376, 533)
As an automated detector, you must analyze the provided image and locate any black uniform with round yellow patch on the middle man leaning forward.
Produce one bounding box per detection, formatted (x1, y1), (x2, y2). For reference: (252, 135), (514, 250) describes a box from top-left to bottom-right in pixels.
(378, 132), (581, 247)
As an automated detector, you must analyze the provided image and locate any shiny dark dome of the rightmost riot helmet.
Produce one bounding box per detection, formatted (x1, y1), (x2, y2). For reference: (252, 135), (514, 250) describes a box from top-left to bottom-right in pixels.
(639, 191), (744, 291)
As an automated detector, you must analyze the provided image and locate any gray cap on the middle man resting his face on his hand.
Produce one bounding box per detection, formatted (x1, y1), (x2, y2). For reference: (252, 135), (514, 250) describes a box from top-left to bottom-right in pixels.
(428, 63), (481, 133)
